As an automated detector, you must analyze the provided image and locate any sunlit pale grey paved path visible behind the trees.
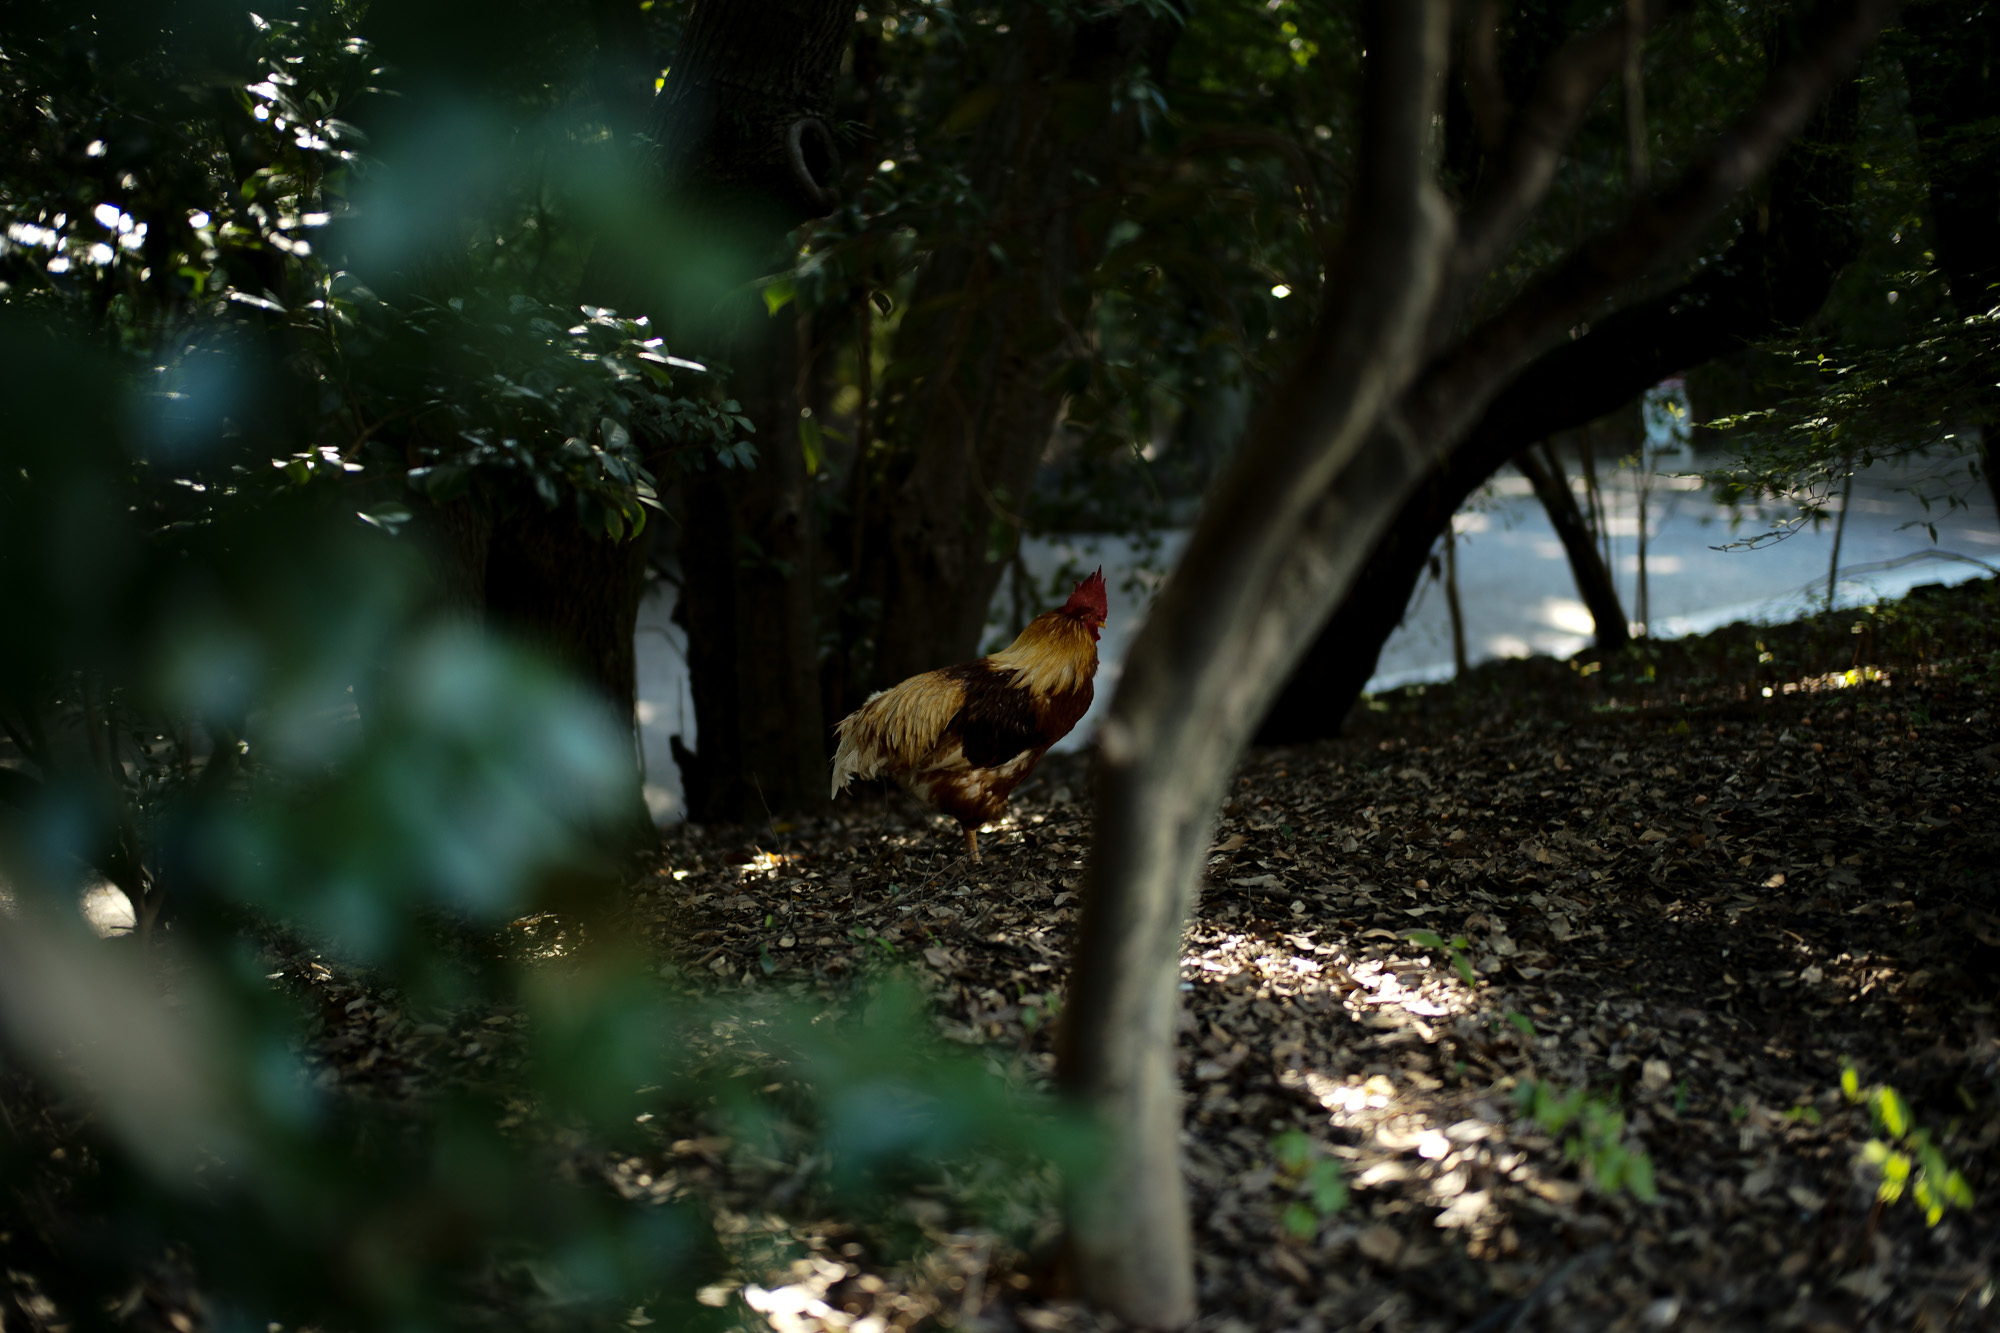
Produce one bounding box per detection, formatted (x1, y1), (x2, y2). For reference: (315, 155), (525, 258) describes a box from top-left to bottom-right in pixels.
(638, 452), (2000, 823)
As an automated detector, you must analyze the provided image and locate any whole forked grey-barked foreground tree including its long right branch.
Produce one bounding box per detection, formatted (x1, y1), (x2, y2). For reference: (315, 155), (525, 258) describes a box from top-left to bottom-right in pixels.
(1060, 0), (1888, 1327)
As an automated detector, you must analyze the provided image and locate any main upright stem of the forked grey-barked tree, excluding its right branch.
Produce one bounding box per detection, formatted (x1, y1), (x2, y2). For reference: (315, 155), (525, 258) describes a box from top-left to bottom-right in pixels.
(1062, 10), (1450, 1329)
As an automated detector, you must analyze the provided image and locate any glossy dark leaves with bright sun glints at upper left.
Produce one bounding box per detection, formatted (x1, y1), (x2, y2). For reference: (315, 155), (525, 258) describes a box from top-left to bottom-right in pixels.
(0, 6), (754, 540)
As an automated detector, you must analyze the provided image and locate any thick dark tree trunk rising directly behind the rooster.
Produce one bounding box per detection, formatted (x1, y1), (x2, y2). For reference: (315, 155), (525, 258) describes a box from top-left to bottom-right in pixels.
(846, 0), (1180, 703)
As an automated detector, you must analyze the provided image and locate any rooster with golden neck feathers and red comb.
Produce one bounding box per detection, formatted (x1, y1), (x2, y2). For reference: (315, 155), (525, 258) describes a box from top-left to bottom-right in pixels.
(832, 568), (1106, 861)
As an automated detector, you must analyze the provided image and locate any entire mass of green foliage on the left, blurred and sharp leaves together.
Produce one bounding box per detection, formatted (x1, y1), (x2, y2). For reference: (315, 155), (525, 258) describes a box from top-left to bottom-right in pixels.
(0, 4), (1080, 1327)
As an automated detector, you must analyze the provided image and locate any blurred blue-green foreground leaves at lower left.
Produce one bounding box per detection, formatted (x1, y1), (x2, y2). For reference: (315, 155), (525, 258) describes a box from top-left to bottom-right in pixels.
(0, 308), (1084, 1327)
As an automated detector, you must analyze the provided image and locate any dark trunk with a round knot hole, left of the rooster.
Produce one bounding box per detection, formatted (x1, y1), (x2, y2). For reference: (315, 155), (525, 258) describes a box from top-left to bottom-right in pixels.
(650, 0), (854, 821)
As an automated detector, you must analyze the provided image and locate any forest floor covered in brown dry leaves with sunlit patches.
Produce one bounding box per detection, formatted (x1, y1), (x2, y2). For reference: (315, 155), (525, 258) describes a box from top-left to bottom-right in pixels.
(632, 580), (2000, 1333)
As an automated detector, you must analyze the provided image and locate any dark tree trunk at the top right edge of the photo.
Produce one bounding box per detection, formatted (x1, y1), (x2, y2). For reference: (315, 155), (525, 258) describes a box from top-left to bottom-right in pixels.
(1902, 0), (2000, 506)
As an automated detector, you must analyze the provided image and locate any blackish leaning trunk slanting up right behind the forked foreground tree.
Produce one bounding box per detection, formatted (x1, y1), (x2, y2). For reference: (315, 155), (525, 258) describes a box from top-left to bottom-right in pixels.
(1258, 67), (1860, 745)
